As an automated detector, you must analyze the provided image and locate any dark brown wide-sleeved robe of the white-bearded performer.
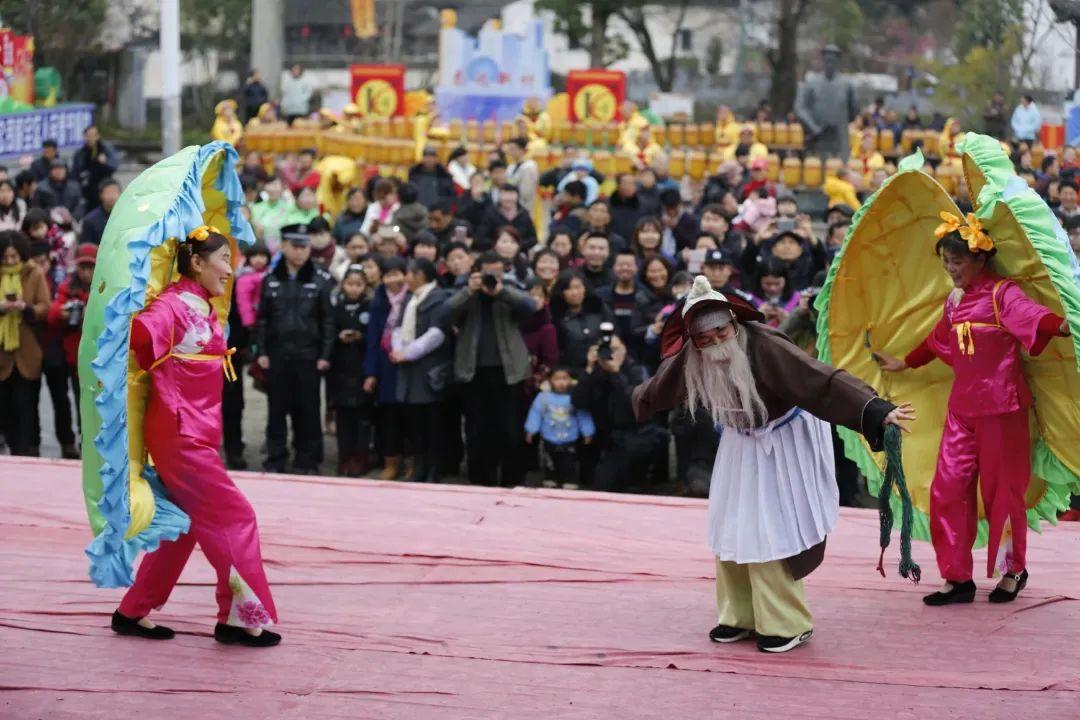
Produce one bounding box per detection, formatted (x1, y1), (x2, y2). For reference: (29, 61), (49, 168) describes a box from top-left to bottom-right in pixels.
(634, 322), (895, 580)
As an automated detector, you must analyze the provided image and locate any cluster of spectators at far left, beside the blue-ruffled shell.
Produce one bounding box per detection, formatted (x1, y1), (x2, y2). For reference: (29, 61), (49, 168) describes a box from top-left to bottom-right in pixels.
(0, 125), (120, 458)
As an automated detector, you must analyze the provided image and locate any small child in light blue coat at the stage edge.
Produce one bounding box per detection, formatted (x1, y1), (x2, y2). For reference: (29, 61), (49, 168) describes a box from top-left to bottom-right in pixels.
(525, 367), (596, 489)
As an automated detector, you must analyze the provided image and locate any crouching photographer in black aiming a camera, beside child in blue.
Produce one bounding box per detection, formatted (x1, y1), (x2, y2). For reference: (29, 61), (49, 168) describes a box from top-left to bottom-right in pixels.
(570, 330), (667, 492)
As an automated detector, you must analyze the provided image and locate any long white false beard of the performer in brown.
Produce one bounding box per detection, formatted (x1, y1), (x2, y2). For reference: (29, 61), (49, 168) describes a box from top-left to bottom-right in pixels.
(686, 332), (769, 430)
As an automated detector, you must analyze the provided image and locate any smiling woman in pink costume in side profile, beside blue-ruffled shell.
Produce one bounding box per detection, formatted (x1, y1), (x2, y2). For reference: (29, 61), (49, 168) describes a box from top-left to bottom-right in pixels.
(112, 226), (281, 647)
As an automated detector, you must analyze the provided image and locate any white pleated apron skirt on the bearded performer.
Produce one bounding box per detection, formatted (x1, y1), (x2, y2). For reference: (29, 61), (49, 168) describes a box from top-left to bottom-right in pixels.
(708, 407), (840, 563)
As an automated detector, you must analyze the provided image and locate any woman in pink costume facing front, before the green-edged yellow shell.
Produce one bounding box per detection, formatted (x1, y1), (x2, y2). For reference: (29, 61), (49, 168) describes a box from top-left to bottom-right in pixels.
(879, 213), (1068, 606)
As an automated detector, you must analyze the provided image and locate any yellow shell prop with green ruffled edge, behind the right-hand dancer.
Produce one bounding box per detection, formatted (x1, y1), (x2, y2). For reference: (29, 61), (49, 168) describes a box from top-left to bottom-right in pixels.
(815, 133), (1080, 544)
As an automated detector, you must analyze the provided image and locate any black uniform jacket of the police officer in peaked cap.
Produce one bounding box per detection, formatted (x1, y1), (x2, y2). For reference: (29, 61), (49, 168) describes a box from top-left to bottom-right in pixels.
(255, 259), (334, 362)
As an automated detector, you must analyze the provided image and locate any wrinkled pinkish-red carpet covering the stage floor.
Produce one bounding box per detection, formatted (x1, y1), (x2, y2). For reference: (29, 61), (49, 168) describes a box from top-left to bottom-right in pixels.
(0, 458), (1080, 720)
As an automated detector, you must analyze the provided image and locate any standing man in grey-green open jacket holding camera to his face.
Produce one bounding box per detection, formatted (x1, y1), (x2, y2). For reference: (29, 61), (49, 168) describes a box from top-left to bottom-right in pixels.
(449, 252), (537, 487)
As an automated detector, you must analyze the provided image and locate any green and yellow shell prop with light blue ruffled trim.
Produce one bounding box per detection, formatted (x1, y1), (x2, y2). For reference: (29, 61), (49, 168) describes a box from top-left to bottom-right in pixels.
(79, 142), (255, 587)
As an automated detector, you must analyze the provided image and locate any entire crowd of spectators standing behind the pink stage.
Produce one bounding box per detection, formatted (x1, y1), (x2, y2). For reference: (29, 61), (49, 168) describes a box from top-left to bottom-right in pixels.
(8, 97), (1080, 504)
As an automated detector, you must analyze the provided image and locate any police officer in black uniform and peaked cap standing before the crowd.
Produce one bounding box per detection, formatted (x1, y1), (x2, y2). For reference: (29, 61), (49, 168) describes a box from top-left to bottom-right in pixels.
(255, 225), (334, 475)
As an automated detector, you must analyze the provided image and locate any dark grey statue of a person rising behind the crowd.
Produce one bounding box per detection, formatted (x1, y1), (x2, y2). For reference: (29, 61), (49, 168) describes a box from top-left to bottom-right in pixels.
(795, 44), (855, 161)
